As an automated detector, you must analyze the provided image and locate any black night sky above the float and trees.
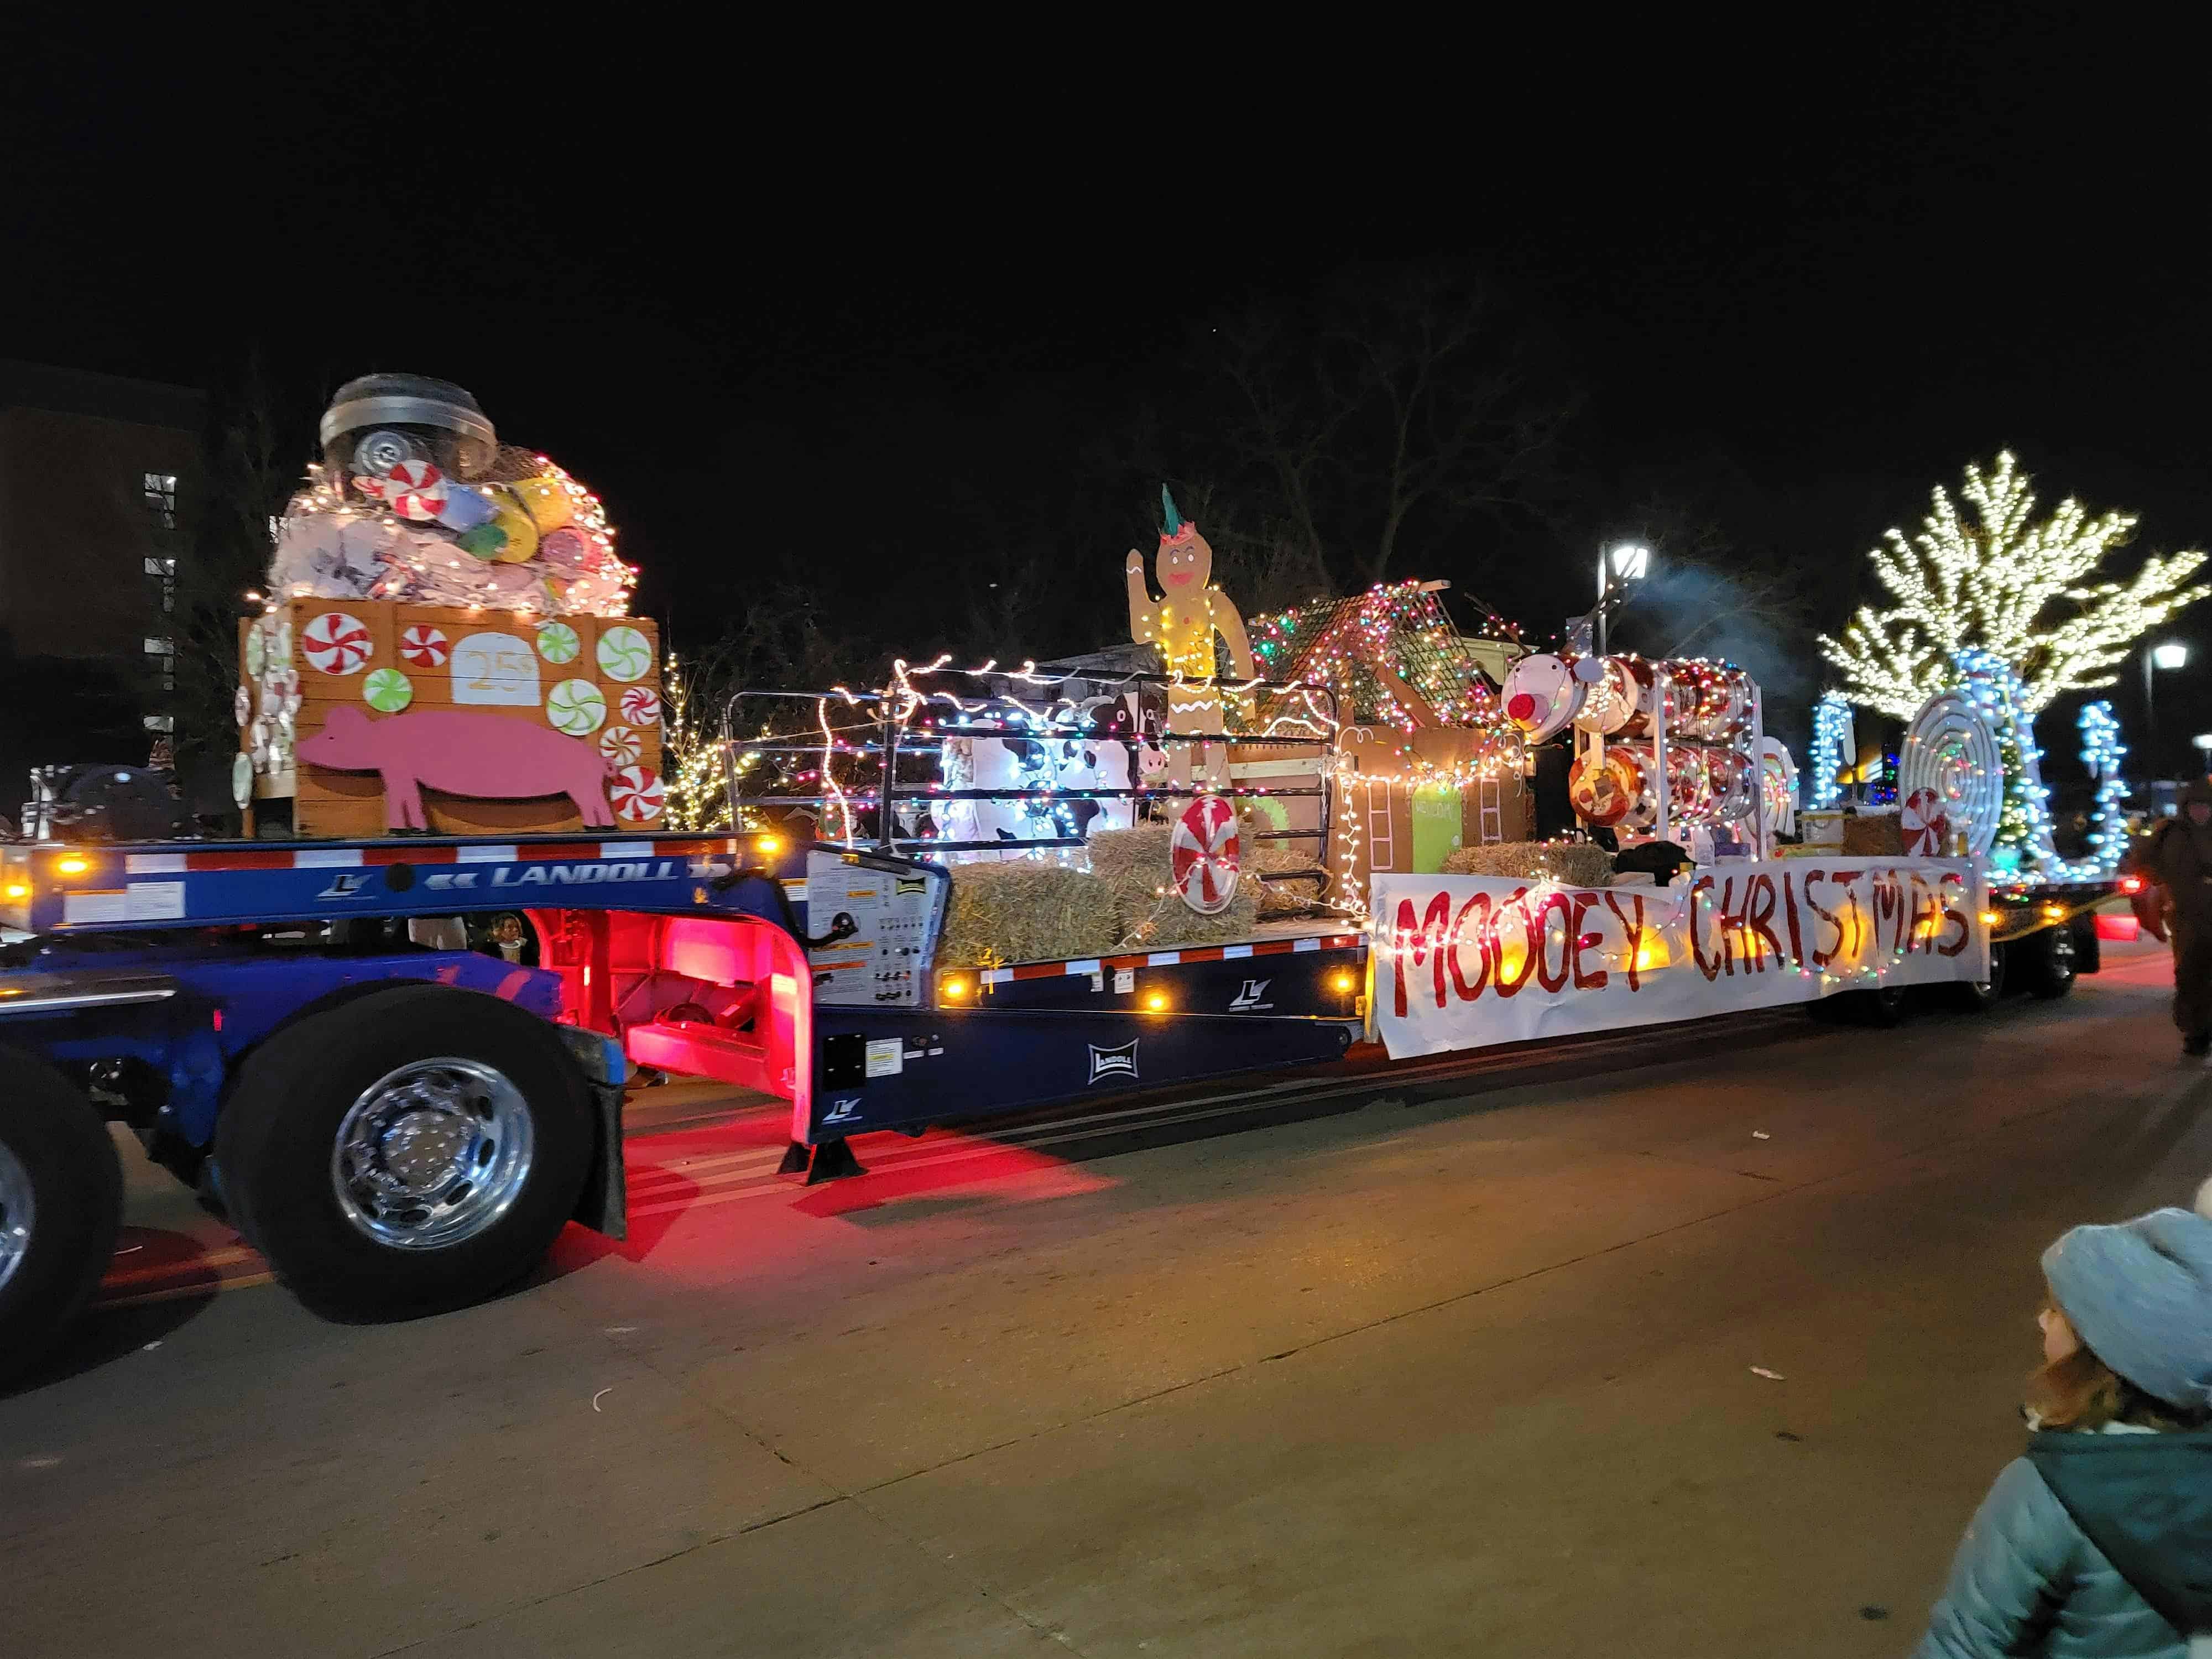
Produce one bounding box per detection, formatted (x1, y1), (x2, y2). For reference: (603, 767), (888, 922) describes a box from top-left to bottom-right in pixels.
(13, 7), (2212, 765)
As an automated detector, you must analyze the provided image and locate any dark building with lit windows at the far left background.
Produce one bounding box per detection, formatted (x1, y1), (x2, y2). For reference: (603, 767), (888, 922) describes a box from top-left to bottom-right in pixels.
(0, 361), (208, 812)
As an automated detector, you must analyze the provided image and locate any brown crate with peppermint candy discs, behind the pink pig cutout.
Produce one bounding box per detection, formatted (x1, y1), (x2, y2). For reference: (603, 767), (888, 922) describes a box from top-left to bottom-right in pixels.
(239, 599), (661, 838)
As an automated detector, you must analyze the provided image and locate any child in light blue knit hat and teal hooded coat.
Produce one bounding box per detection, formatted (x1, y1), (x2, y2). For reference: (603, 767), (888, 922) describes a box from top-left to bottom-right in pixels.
(1913, 1181), (2212, 1659)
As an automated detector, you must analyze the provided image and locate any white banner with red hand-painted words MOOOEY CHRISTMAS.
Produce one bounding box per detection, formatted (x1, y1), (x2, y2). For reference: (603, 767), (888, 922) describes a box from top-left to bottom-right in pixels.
(1369, 858), (1989, 1060)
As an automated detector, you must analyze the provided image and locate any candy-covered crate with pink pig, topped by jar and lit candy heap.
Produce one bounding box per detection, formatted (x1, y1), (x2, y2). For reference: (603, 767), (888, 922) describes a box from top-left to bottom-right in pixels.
(232, 374), (664, 838)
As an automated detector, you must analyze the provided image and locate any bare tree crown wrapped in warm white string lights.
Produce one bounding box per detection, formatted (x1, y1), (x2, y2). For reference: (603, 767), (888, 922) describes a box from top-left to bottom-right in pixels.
(1820, 453), (2212, 719)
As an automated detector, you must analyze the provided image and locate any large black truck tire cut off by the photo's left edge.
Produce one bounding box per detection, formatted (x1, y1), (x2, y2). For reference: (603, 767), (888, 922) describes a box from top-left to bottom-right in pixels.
(0, 1048), (124, 1385)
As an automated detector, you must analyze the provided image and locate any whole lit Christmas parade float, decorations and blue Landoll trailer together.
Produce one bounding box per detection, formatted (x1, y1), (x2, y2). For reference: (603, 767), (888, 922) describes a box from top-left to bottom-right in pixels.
(0, 451), (2115, 1369)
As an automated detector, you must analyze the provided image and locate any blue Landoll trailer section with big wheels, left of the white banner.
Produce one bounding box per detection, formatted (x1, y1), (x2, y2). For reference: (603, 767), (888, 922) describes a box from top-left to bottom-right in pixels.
(0, 834), (1367, 1376)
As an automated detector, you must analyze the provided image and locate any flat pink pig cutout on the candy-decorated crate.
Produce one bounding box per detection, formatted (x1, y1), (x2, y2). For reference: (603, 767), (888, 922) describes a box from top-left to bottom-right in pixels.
(299, 706), (615, 830)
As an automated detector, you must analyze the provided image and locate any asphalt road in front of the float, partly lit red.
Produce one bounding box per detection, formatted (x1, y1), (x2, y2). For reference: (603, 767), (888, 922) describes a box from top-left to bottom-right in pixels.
(0, 947), (2212, 1659)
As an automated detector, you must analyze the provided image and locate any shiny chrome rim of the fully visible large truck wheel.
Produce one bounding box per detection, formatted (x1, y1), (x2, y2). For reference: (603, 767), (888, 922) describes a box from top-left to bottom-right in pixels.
(330, 1057), (533, 1250)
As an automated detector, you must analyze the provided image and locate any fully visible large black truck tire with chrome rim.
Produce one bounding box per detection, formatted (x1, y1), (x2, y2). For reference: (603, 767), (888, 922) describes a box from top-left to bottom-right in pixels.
(215, 984), (595, 1318)
